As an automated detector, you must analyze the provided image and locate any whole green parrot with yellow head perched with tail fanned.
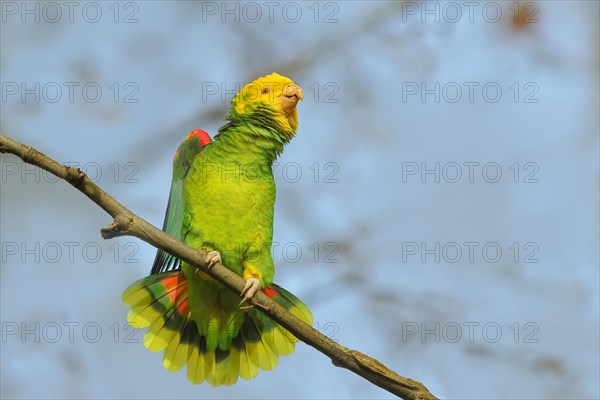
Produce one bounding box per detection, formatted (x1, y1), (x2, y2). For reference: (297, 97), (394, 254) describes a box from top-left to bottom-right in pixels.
(122, 73), (313, 386)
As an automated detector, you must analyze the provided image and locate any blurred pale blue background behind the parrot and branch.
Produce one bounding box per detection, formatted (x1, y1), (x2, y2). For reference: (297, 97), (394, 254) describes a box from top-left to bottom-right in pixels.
(0, 1), (600, 399)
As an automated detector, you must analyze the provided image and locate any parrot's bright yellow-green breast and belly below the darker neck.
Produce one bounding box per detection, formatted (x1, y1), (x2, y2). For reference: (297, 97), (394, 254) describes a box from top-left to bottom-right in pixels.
(184, 146), (275, 276)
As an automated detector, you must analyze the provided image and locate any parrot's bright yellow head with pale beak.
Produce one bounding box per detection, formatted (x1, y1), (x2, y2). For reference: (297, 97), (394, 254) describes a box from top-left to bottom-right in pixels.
(231, 72), (304, 139)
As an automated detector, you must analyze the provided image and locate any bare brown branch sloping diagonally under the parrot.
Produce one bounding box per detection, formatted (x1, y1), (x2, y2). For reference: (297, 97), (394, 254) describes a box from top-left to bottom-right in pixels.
(0, 135), (437, 400)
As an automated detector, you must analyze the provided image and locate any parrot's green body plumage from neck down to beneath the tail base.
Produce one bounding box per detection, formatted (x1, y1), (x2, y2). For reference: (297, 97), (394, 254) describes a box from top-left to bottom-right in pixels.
(182, 98), (283, 350)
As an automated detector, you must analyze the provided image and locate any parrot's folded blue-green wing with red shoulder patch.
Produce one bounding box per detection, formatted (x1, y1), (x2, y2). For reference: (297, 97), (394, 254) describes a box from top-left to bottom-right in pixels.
(150, 129), (211, 274)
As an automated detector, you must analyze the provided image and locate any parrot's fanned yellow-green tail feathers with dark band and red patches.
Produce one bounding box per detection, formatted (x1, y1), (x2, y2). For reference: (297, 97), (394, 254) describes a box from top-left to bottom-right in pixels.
(123, 270), (312, 386)
